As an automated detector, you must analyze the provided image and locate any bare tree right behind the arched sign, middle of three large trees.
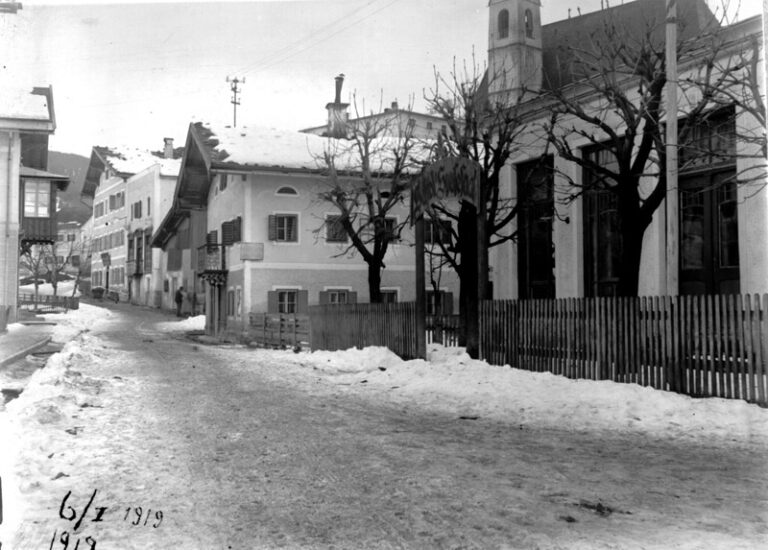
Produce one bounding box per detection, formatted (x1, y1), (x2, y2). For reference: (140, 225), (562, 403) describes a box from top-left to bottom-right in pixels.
(425, 63), (536, 356)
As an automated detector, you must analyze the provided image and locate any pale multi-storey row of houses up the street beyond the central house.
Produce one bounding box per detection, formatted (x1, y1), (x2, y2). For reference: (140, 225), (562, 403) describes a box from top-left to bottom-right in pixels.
(82, 143), (180, 307)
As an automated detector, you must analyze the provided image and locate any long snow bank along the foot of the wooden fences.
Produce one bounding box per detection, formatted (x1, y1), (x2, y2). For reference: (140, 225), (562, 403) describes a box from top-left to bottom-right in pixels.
(271, 345), (768, 442)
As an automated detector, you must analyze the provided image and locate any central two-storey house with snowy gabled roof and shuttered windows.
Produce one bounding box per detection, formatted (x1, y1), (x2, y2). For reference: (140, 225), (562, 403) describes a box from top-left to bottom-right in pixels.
(152, 123), (456, 333)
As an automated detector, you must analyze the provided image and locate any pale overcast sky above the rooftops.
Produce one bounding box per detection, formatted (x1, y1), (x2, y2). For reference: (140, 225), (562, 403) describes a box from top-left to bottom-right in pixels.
(0, 0), (762, 155)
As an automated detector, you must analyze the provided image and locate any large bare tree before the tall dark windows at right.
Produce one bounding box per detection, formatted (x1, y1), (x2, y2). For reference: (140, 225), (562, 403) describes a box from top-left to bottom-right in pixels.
(542, 3), (764, 296)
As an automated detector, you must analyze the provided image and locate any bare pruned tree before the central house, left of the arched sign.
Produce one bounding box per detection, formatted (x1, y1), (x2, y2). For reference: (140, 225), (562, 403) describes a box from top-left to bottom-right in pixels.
(317, 97), (419, 303)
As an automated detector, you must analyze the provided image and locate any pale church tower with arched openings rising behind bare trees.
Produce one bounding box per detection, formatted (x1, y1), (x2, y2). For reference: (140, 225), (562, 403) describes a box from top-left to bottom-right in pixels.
(488, 0), (542, 105)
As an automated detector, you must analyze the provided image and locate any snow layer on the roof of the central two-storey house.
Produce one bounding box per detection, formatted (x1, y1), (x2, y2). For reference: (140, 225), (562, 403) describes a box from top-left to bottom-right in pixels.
(201, 123), (422, 175)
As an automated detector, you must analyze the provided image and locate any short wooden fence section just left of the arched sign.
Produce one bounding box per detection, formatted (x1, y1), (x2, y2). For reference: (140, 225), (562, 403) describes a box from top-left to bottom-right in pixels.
(309, 302), (417, 359)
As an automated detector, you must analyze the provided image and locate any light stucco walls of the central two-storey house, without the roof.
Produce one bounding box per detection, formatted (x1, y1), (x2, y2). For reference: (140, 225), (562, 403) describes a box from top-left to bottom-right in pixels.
(207, 172), (458, 319)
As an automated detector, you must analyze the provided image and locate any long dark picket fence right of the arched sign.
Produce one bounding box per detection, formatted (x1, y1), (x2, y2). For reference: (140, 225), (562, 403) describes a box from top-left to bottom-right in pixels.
(480, 295), (768, 406)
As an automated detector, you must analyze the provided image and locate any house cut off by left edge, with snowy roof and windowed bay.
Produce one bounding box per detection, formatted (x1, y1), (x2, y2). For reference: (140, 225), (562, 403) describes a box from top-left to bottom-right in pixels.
(0, 84), (68, 330)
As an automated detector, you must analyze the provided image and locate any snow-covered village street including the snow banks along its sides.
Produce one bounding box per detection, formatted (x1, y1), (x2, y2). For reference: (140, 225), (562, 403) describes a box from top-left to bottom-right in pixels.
(0, 304), (768, 549)
